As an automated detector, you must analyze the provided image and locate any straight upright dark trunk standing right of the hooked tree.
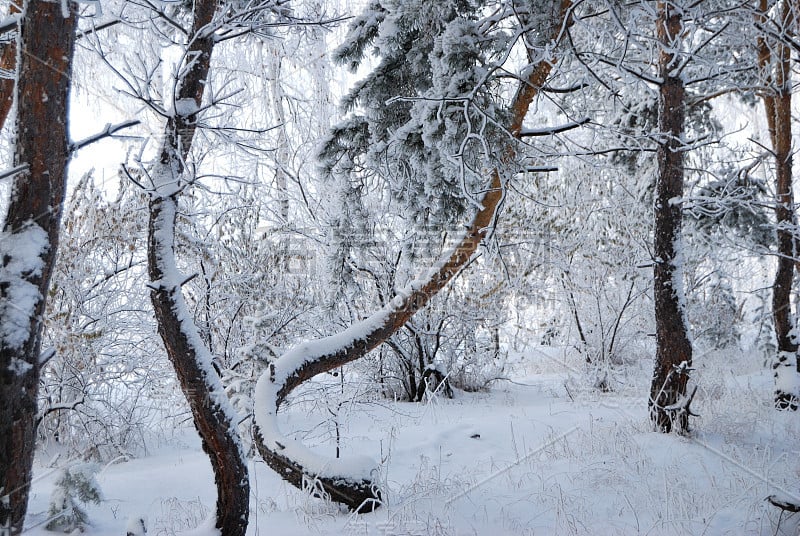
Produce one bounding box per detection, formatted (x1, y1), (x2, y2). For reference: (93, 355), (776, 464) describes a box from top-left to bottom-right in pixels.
(649, 2), (692, 432)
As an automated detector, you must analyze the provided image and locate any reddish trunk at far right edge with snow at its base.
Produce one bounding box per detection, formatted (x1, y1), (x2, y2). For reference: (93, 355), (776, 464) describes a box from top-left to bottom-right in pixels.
(757, 0), (798, 410)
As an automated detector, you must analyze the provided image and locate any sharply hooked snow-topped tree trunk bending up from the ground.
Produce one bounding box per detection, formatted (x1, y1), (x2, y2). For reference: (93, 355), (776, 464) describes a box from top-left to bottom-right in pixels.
(253, 0), (572, 513)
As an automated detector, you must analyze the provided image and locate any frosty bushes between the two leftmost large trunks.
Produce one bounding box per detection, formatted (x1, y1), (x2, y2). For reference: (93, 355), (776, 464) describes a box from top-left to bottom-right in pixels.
(39, 176), (170, 460)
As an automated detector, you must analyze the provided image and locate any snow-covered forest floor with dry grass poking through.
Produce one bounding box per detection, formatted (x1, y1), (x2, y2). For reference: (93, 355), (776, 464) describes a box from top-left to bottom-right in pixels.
(18, 348), (800, 536)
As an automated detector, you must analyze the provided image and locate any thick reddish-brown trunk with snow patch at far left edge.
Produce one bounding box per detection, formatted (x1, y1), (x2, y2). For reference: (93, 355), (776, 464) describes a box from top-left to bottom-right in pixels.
(0, 0), (77, 534)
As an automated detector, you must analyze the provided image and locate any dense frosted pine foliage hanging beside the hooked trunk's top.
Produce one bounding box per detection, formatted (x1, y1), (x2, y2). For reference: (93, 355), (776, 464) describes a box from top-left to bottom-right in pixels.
(321, 0), (508, 224)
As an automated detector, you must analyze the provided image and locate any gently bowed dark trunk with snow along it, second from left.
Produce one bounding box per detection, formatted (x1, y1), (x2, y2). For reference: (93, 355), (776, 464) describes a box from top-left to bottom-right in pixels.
(147, 0), (250, 536)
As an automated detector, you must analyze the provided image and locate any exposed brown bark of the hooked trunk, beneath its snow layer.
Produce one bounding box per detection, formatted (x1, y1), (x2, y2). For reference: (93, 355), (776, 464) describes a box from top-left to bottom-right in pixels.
(253, 0), (572, 513)
